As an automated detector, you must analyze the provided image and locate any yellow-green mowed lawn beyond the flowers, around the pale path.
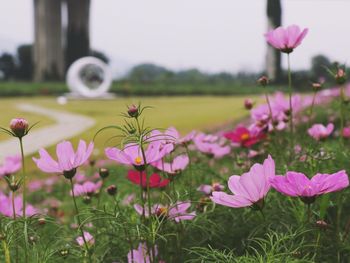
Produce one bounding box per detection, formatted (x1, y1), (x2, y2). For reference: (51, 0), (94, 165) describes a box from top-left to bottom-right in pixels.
(0, 96), (259, 171)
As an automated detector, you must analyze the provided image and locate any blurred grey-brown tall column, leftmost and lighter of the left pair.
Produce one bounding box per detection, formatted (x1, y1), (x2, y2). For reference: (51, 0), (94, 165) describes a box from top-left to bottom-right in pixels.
(33, 0), (64, 81)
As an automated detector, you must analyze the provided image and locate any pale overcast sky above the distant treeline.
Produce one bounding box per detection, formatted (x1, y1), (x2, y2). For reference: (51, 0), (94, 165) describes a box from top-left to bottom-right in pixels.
(0, 0), (350, 75)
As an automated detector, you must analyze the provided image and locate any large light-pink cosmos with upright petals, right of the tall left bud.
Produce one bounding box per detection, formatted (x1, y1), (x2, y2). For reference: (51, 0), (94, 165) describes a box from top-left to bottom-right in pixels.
(33, 140), (94, 179)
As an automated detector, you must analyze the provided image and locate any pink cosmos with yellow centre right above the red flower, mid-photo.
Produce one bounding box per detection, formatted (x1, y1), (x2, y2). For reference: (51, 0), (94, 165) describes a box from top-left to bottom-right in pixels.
(105, 142), (164, 168)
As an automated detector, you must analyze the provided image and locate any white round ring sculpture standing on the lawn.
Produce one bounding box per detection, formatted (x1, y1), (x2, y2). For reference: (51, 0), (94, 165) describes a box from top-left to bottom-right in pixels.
(67, 57), (112, 98)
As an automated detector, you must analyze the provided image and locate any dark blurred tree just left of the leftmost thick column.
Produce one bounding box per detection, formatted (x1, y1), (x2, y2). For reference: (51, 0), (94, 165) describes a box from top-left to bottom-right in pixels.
(16, 45), (34, 80)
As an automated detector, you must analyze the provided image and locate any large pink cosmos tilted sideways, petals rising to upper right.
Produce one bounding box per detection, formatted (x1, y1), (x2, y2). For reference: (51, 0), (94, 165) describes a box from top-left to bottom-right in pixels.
(211, 155), (275, 209)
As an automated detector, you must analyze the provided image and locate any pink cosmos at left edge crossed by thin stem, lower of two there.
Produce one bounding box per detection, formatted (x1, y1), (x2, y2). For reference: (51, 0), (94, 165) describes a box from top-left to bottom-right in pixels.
(0, 192), (38, 217)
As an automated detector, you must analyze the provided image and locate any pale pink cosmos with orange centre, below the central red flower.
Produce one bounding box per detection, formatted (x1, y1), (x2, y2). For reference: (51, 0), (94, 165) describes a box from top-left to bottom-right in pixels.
(134, 201), (196, 223)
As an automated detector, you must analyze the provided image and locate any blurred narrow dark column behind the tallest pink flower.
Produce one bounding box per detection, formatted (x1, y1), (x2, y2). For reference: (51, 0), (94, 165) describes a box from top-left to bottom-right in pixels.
(266, 0), (282, 82)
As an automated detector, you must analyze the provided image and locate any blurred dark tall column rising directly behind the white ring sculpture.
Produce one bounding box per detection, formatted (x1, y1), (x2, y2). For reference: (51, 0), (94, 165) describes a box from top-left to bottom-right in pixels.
(66, 0), (90, 68)
